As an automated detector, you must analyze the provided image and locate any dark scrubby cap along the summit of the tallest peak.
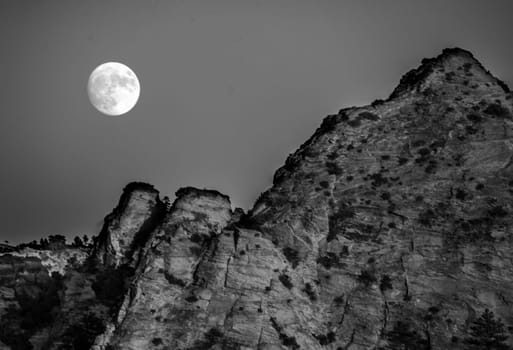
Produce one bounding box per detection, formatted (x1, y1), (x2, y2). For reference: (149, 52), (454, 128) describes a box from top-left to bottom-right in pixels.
(388, 47), (510, 100)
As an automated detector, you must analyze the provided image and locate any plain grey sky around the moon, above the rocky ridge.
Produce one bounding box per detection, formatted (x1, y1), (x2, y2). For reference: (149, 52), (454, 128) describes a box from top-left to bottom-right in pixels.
(0, 0), (513, 243)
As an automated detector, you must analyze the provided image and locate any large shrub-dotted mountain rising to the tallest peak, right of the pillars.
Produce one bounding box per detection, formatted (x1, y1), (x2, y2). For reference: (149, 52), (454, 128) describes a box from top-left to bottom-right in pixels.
(243, 49), (513, 349)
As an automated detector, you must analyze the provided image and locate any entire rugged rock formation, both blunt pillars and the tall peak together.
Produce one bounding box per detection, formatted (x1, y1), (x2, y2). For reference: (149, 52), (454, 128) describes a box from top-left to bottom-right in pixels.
(0, 49), (513, 350)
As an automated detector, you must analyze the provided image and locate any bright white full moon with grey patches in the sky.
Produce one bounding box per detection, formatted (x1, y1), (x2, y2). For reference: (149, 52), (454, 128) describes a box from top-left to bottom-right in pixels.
(87, 62), (141, 115)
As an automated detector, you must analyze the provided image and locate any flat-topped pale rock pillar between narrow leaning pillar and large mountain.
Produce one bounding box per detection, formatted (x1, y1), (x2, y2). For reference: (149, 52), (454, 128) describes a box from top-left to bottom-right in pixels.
(98, 187), (231, 349)
